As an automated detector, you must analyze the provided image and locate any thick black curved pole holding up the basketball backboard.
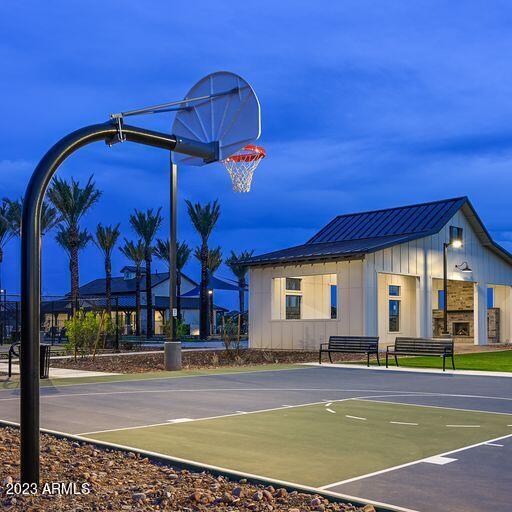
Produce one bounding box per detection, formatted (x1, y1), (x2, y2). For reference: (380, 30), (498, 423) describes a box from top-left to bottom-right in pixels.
(20, 119), (216, 485)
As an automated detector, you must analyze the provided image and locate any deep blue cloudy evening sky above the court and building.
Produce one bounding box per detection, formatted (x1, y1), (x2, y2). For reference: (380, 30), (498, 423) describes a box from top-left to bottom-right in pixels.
(0, 0), (512, 306)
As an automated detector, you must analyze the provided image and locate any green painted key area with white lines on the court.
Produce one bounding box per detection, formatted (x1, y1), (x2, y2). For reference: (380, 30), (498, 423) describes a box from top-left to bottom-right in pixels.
(85, 399), (512, 487)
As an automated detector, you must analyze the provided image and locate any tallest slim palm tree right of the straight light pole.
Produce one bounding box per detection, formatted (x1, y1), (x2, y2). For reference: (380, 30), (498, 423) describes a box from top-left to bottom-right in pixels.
(186, 200), (220, 338)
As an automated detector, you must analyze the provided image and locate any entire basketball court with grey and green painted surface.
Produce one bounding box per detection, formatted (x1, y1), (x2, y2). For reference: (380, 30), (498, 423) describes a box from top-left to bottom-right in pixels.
(0, 367), (512, 512)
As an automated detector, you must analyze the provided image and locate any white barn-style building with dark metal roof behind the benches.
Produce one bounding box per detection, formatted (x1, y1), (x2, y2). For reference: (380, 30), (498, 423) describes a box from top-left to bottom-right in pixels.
(248, 197), (512, 350)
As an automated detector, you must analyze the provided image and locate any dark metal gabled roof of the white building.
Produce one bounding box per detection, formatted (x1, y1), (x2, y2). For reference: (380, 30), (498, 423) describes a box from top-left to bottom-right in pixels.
(247, 197), (512, 266)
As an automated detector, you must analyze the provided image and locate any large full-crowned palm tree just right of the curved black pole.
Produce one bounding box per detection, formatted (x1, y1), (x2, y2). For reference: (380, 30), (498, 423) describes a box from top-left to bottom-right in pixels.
(48, 176), (101, 310)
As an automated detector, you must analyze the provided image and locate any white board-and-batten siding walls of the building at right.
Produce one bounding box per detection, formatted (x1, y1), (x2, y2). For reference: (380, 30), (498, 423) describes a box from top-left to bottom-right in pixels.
(249, 209), (512, 350)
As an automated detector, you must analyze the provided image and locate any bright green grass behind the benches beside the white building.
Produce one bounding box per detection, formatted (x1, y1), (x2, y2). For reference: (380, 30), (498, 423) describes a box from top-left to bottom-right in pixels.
(389, 350), (512, 372)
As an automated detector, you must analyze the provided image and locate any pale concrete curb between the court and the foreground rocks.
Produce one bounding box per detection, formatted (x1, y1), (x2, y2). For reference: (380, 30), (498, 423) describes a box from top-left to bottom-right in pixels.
(0, 419), (408, 512)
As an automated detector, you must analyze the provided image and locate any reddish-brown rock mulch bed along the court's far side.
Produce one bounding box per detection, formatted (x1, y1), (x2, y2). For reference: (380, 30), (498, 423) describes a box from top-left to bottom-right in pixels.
(51, 349), (361, 373)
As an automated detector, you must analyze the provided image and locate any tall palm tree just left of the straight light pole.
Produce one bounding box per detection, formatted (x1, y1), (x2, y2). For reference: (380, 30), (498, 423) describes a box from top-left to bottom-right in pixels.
(130, 208), (163, 338)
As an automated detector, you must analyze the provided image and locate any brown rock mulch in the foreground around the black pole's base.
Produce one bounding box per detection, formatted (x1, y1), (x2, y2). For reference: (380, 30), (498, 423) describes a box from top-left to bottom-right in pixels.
(0, 427), (375, 512)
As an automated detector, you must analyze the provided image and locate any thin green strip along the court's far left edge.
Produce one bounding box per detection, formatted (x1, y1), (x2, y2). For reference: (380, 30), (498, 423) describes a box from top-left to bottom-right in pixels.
(0, 364), (307, 389)
